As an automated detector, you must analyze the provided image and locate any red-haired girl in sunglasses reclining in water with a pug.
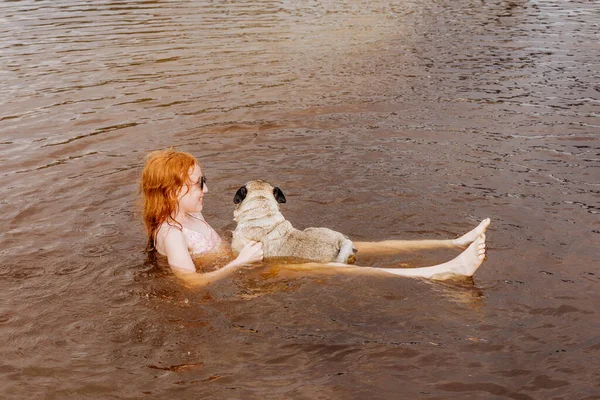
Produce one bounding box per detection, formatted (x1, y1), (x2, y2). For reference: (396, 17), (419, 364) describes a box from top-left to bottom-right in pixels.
(140, 150), (490, 284)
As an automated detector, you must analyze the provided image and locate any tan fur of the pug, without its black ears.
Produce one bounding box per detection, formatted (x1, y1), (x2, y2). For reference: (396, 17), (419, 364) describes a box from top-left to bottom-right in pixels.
(231, 180), (355, 263)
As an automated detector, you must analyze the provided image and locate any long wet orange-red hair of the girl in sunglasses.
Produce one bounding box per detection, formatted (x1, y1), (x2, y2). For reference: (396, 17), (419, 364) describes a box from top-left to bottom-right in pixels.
(140, 149), (199, 251)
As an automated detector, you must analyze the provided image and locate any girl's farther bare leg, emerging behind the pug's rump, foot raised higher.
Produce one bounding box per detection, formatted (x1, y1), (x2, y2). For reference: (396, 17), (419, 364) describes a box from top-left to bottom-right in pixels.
(354, 218), (490, 254)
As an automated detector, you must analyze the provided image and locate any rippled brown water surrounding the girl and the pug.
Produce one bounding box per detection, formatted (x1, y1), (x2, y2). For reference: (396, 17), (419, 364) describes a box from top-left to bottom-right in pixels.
(0, 0), (600, 399)
